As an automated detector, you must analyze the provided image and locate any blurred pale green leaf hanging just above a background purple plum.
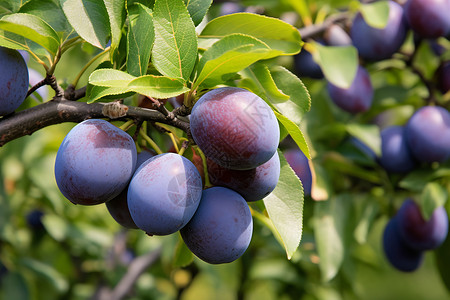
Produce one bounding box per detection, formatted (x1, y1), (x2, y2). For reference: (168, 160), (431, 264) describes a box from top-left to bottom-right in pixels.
(314, 43), (359, 88)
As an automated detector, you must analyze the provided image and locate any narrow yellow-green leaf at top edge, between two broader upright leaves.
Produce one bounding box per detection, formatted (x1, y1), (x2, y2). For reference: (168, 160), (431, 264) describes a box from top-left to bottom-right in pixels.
(103, 0), (125, 57)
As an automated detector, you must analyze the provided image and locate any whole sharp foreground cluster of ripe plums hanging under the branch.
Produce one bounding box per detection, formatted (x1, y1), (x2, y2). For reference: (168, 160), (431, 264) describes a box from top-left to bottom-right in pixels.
(55, 87), (280, 264)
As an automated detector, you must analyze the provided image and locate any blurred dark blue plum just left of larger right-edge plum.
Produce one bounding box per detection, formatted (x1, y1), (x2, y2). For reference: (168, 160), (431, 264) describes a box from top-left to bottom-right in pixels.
(379, 126), (416, 173)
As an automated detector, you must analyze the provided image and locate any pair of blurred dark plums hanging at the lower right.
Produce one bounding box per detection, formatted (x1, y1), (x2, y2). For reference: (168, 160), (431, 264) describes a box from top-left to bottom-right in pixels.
(383, 199), (448, 272)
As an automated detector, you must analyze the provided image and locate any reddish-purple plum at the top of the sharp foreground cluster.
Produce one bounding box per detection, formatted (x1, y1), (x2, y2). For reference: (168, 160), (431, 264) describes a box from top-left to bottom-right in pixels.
(190, 87), (280, 170)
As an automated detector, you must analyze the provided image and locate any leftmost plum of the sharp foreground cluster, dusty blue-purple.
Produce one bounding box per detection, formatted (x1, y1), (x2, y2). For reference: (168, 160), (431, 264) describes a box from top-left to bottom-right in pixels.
(55, 119), (137, 205)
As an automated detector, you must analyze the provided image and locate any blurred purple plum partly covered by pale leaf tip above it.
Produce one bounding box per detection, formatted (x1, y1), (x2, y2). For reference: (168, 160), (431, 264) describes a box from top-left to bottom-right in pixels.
(327, 66), (373, 113)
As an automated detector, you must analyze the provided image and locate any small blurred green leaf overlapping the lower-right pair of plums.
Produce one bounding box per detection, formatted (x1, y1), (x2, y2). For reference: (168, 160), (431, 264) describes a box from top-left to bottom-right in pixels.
(419, 182), (448, 220)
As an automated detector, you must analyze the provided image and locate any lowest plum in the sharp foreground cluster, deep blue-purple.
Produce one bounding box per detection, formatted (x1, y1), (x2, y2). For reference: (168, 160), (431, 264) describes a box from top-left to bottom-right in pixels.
(180, 187), (253, 264)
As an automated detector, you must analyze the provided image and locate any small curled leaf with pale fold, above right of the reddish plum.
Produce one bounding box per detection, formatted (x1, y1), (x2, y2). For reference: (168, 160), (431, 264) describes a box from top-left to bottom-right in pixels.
(271, 66), (311, 124)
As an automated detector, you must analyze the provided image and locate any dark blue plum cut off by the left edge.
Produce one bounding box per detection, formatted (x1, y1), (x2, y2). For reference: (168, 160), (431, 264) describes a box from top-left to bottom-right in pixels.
(0, 47), (28, 116)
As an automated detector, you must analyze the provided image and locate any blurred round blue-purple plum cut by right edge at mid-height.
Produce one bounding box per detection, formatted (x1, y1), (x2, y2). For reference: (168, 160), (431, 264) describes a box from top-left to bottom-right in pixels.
(405, 106), (450, 163)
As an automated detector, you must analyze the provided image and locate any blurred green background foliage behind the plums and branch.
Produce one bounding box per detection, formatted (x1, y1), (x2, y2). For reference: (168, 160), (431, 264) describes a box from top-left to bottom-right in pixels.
(0, 0), (450, 300)
